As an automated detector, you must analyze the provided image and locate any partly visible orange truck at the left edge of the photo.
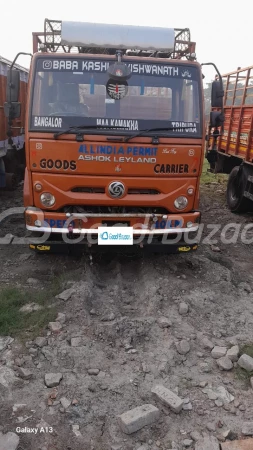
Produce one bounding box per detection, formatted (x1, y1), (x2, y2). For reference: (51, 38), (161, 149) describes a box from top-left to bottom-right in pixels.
(0, 56), (28, 189)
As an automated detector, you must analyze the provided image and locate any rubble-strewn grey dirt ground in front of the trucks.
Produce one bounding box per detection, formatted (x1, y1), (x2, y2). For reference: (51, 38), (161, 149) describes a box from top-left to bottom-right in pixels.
(0, 183), (253, 450)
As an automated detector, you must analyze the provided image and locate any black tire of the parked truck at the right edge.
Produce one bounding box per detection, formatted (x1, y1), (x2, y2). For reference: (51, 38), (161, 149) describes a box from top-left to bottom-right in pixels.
(227, 166), (253, 213)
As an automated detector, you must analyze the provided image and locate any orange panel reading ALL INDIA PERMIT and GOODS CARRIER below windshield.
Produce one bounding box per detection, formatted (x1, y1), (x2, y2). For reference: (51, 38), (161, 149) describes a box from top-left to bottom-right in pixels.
(27, 139), (201, 179)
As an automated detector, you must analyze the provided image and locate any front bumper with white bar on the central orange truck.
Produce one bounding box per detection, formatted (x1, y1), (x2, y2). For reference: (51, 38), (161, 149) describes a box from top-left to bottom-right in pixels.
(25, 208), (200, 253)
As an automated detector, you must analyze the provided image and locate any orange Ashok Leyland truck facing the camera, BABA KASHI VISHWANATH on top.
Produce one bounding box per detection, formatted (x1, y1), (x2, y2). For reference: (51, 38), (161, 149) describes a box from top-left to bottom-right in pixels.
(3, 19), (213, 253)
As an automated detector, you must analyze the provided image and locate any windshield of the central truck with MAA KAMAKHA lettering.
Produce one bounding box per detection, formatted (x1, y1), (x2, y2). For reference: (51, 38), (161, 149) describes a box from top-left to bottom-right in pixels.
(30, 57), (202, 137)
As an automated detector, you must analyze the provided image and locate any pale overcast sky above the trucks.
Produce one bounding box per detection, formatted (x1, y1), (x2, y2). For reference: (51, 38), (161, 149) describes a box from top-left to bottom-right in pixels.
(0, 0), (253, 82)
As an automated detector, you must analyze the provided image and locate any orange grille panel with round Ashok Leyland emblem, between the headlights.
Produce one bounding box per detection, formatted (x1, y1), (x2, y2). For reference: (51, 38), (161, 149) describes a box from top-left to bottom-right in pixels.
(29, 172), (197, 213)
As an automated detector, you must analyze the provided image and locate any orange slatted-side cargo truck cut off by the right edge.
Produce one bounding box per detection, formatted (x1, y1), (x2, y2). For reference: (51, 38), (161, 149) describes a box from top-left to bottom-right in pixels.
(206, 67), (253, 213)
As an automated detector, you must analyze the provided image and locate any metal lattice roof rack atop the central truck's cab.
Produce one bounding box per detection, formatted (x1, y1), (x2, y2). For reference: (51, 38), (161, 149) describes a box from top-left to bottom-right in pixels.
(33, 19), (196, 60)
